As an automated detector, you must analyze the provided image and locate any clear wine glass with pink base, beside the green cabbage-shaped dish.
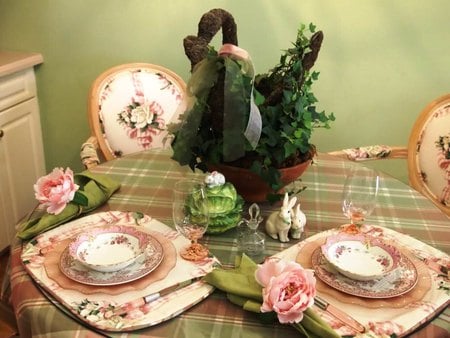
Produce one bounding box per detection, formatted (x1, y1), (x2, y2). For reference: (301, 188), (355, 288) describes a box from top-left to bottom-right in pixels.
(172, 179), (209, 261)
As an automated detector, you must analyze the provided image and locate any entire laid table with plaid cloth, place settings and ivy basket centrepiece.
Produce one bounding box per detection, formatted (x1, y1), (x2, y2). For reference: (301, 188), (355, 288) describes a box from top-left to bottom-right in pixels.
(7, 9), (450, 338)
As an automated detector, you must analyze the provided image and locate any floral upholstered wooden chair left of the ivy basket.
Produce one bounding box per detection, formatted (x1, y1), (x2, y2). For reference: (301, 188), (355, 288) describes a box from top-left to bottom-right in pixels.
(80, 63), (186, 168)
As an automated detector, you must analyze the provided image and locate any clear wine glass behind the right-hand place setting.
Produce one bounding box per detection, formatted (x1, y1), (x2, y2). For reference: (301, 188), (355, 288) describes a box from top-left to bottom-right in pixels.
(342, 166), (380, 227)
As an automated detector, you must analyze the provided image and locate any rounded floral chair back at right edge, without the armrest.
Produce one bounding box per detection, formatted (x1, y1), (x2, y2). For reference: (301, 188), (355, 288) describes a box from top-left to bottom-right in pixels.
(408, 94), (450, 215)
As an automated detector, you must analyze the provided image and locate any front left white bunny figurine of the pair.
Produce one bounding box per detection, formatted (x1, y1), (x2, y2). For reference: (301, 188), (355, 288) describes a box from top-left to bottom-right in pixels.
(266, 193), (297, 242)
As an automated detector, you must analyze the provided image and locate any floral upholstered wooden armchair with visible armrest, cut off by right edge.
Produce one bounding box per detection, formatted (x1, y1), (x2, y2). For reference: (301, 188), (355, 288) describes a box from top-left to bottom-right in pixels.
(329, 94), (450, 216)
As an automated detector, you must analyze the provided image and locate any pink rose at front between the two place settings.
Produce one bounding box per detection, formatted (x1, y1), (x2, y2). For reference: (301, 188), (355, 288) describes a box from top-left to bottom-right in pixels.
(255, 258), (316, 323)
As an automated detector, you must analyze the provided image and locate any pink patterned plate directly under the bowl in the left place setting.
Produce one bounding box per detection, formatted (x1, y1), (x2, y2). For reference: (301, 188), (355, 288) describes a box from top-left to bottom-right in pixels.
(59, 231), (164, 286)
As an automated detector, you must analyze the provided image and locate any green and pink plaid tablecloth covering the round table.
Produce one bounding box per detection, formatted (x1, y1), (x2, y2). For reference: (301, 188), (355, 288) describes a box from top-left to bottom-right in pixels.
(11, 151), (450, 338)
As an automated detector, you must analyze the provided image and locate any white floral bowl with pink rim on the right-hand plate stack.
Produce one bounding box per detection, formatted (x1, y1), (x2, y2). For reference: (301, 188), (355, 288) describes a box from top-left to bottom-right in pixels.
(321, 234), (401, 281)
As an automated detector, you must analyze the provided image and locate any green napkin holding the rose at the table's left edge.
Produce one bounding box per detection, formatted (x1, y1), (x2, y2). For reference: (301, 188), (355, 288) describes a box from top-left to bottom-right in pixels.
(17, 171), (120, 239)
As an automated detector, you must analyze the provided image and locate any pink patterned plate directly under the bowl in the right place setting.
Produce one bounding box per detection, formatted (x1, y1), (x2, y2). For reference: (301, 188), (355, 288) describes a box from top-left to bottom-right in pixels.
(311, 247), (418, 299)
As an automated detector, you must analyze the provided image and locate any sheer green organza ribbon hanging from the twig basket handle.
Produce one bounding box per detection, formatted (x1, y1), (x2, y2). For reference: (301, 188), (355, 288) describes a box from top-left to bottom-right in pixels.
(173, 47), (261, 164)
